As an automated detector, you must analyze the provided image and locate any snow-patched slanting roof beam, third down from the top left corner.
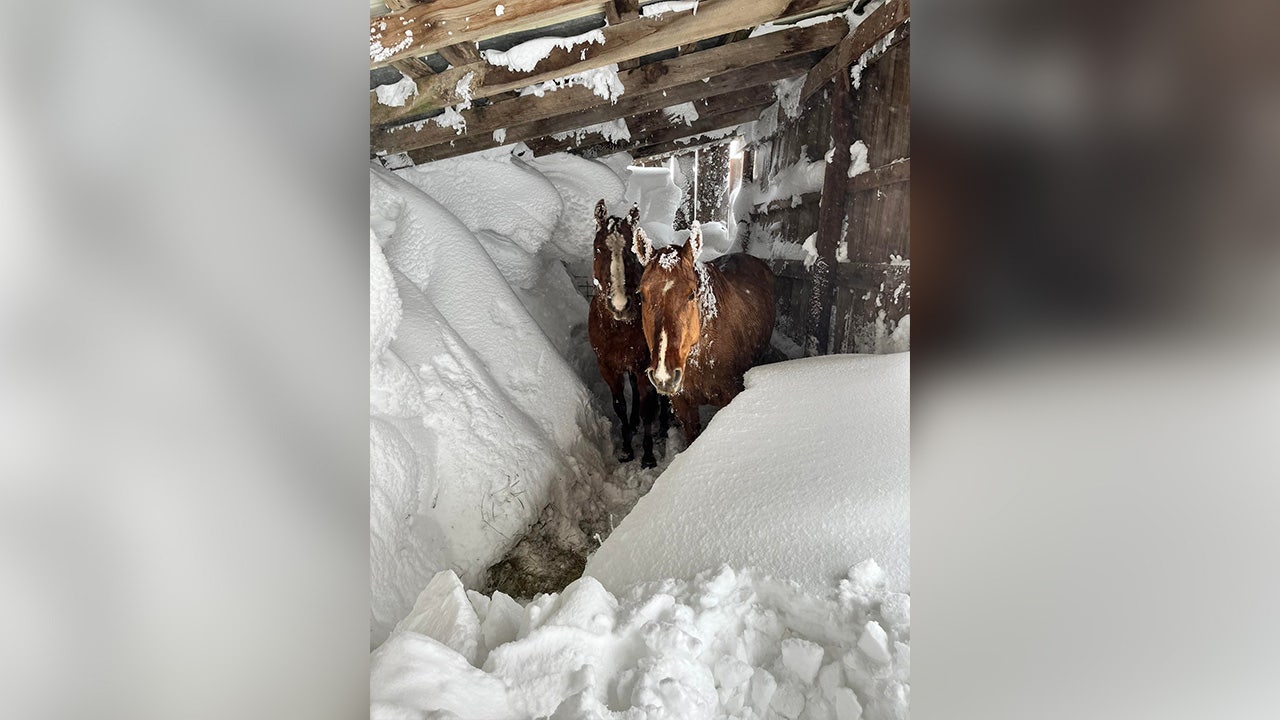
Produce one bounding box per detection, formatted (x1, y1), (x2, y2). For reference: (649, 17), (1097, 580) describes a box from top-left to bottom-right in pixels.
(370, 20), (846, 137)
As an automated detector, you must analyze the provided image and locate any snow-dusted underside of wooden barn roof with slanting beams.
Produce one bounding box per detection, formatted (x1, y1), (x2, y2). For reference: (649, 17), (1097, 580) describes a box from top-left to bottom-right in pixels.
(370, 0), (910, 164)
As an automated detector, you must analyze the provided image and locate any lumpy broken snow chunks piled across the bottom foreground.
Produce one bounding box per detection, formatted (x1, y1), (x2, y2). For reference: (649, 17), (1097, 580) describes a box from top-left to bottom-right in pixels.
(370, 562), (911, 720)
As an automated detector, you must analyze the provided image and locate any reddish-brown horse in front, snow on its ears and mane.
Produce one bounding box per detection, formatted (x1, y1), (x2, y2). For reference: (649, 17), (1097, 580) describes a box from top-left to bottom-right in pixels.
(632, 222), (773, 445)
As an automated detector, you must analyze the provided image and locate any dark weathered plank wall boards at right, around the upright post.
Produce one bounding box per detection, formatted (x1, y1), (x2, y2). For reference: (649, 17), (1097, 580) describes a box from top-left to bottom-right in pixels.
(749, 37), (911, 354)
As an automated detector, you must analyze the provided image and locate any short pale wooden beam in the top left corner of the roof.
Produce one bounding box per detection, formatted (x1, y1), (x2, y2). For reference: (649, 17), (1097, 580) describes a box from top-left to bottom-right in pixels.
(369, 0), (608, 68)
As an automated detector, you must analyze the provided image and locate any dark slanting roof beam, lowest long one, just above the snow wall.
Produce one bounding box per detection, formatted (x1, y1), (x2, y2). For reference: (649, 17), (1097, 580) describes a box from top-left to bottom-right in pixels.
(372, 54), (815, 161)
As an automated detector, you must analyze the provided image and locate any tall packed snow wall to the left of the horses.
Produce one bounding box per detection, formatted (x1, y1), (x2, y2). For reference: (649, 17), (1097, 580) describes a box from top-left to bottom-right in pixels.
(370, 149), (634, 644)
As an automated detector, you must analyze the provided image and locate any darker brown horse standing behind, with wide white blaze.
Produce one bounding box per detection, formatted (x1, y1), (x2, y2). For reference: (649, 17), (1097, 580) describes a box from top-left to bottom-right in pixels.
(586, 200), (658, 468)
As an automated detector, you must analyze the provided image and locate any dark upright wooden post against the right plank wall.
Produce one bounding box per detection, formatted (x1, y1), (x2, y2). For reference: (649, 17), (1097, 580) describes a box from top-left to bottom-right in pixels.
(805, 72), (854, 355)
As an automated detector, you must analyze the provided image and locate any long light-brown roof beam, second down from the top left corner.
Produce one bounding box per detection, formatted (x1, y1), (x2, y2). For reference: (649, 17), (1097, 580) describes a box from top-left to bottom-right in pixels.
(409, 0), (847, 109)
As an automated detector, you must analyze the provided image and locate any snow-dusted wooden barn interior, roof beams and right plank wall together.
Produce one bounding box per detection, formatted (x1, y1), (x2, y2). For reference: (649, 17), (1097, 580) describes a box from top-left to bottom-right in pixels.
(370, 0), (911, 355)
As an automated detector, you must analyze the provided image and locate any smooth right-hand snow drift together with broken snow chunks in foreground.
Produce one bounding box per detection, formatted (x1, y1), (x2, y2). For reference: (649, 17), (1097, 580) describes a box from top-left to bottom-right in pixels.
(370, 355), (910, 720)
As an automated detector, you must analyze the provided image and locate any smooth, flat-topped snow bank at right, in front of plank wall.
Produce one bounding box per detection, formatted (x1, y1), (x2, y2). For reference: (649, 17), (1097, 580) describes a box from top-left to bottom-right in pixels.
(586, 352), (910, 592)
